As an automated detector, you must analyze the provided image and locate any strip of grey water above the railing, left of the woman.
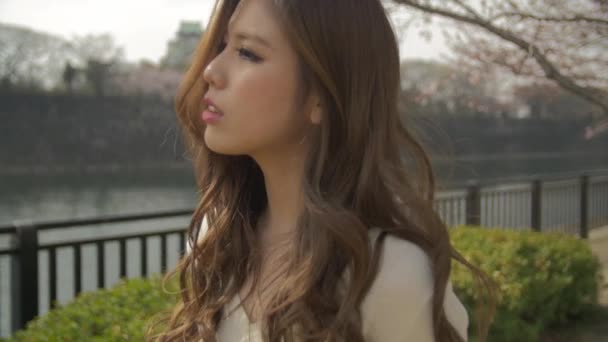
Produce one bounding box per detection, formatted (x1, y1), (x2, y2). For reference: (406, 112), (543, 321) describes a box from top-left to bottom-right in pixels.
(0, 170), (196, 225)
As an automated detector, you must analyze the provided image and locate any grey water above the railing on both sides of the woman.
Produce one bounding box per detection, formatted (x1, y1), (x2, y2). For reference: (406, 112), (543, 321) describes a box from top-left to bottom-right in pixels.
(0, 149), (608, 225)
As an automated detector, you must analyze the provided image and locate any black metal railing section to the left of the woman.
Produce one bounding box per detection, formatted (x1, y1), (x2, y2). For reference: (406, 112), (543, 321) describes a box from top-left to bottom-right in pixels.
(0, 210), (192, 335)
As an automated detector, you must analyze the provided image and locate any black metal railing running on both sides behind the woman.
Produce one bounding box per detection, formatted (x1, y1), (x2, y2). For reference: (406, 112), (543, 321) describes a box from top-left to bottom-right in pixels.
(0, 170), (608, 336)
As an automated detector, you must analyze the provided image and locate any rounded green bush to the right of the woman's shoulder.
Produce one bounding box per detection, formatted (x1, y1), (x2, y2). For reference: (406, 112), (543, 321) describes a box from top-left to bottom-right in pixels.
(450, 226), (600, 342)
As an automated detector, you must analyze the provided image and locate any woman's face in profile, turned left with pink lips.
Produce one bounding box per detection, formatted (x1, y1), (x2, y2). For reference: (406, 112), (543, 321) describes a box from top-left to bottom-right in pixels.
(201, 0), (318, 157)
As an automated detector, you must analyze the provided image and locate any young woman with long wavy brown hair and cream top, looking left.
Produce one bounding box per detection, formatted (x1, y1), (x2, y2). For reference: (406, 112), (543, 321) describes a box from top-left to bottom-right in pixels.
(155, 0), (494, 342)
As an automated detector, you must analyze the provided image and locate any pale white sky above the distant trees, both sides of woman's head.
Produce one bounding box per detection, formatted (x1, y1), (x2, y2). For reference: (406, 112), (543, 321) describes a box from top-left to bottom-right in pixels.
(0, 0), (446, 62)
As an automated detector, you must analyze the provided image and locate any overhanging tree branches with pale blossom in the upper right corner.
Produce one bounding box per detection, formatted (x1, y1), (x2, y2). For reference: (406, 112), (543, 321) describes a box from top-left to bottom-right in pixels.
(392, 0), (608, 136)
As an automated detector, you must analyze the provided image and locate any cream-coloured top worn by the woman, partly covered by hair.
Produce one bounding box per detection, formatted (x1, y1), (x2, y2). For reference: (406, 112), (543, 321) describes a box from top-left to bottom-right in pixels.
(195, 223), (469, 342)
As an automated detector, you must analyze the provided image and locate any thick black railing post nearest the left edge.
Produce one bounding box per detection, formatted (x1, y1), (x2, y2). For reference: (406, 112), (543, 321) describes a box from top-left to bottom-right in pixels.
(11, 223), (38, 330)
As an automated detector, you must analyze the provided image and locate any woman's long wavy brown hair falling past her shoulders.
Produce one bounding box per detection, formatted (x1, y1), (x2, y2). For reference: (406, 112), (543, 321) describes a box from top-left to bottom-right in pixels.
(150, 0), (494, 342)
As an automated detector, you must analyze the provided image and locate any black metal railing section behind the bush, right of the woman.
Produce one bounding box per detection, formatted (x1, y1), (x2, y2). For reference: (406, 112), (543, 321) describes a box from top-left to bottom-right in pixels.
(435, 170), (608, 238)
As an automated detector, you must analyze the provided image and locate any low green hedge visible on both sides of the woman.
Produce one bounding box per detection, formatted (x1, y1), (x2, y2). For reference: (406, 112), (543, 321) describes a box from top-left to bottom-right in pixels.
(4, 226), (600, 342)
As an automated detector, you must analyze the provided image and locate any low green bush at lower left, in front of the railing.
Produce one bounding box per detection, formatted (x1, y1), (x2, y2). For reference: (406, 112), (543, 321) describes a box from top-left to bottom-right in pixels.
(2, 276), (178, 342)
